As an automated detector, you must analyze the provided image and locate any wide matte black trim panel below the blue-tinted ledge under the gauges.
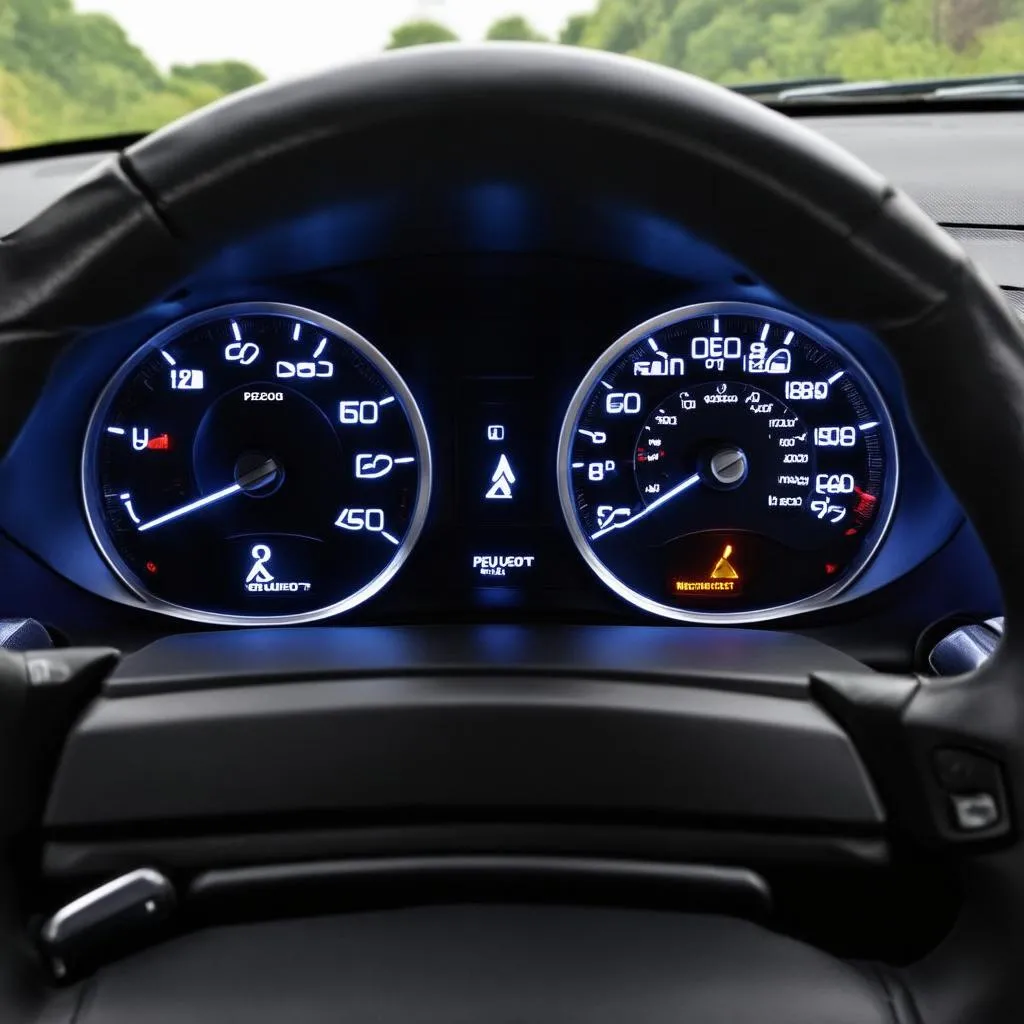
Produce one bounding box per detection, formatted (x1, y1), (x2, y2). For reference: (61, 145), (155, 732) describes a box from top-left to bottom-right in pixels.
(45, 673), (885, 835)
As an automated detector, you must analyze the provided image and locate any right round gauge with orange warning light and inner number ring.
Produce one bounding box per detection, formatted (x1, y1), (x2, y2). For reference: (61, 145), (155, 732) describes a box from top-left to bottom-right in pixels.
(558, 302), (897, 623)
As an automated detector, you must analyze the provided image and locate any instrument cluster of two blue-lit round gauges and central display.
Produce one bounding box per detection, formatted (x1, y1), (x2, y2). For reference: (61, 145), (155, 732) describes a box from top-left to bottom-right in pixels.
(81, 301), (899, 625)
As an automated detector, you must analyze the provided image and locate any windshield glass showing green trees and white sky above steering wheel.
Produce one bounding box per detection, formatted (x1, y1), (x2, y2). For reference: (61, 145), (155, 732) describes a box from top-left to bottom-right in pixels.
(0, 0), (1024, 148)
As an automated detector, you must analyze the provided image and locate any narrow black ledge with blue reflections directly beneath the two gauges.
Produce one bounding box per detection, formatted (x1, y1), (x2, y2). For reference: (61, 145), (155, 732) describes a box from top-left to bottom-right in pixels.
(105, 625), (863, 697)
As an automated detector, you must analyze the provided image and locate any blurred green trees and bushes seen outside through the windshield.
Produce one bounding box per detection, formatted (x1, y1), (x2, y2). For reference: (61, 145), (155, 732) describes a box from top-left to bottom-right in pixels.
(0, 0), (1024, 148)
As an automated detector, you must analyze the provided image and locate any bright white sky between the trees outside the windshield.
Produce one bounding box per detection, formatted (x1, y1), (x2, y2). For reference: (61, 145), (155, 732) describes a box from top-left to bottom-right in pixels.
(77, 0), (595, 78)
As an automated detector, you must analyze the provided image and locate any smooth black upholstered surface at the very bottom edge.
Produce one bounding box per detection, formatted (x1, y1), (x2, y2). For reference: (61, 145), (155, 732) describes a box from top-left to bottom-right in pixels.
(66, 906), (913, 1024)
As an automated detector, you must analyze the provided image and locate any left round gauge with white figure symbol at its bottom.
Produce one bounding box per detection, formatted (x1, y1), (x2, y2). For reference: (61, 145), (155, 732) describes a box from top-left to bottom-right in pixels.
(82, 303), (430, 625)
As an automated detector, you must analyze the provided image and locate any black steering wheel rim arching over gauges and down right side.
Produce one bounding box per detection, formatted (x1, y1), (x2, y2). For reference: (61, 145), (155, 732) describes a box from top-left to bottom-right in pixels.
(0, 45), (1024, 1024)
